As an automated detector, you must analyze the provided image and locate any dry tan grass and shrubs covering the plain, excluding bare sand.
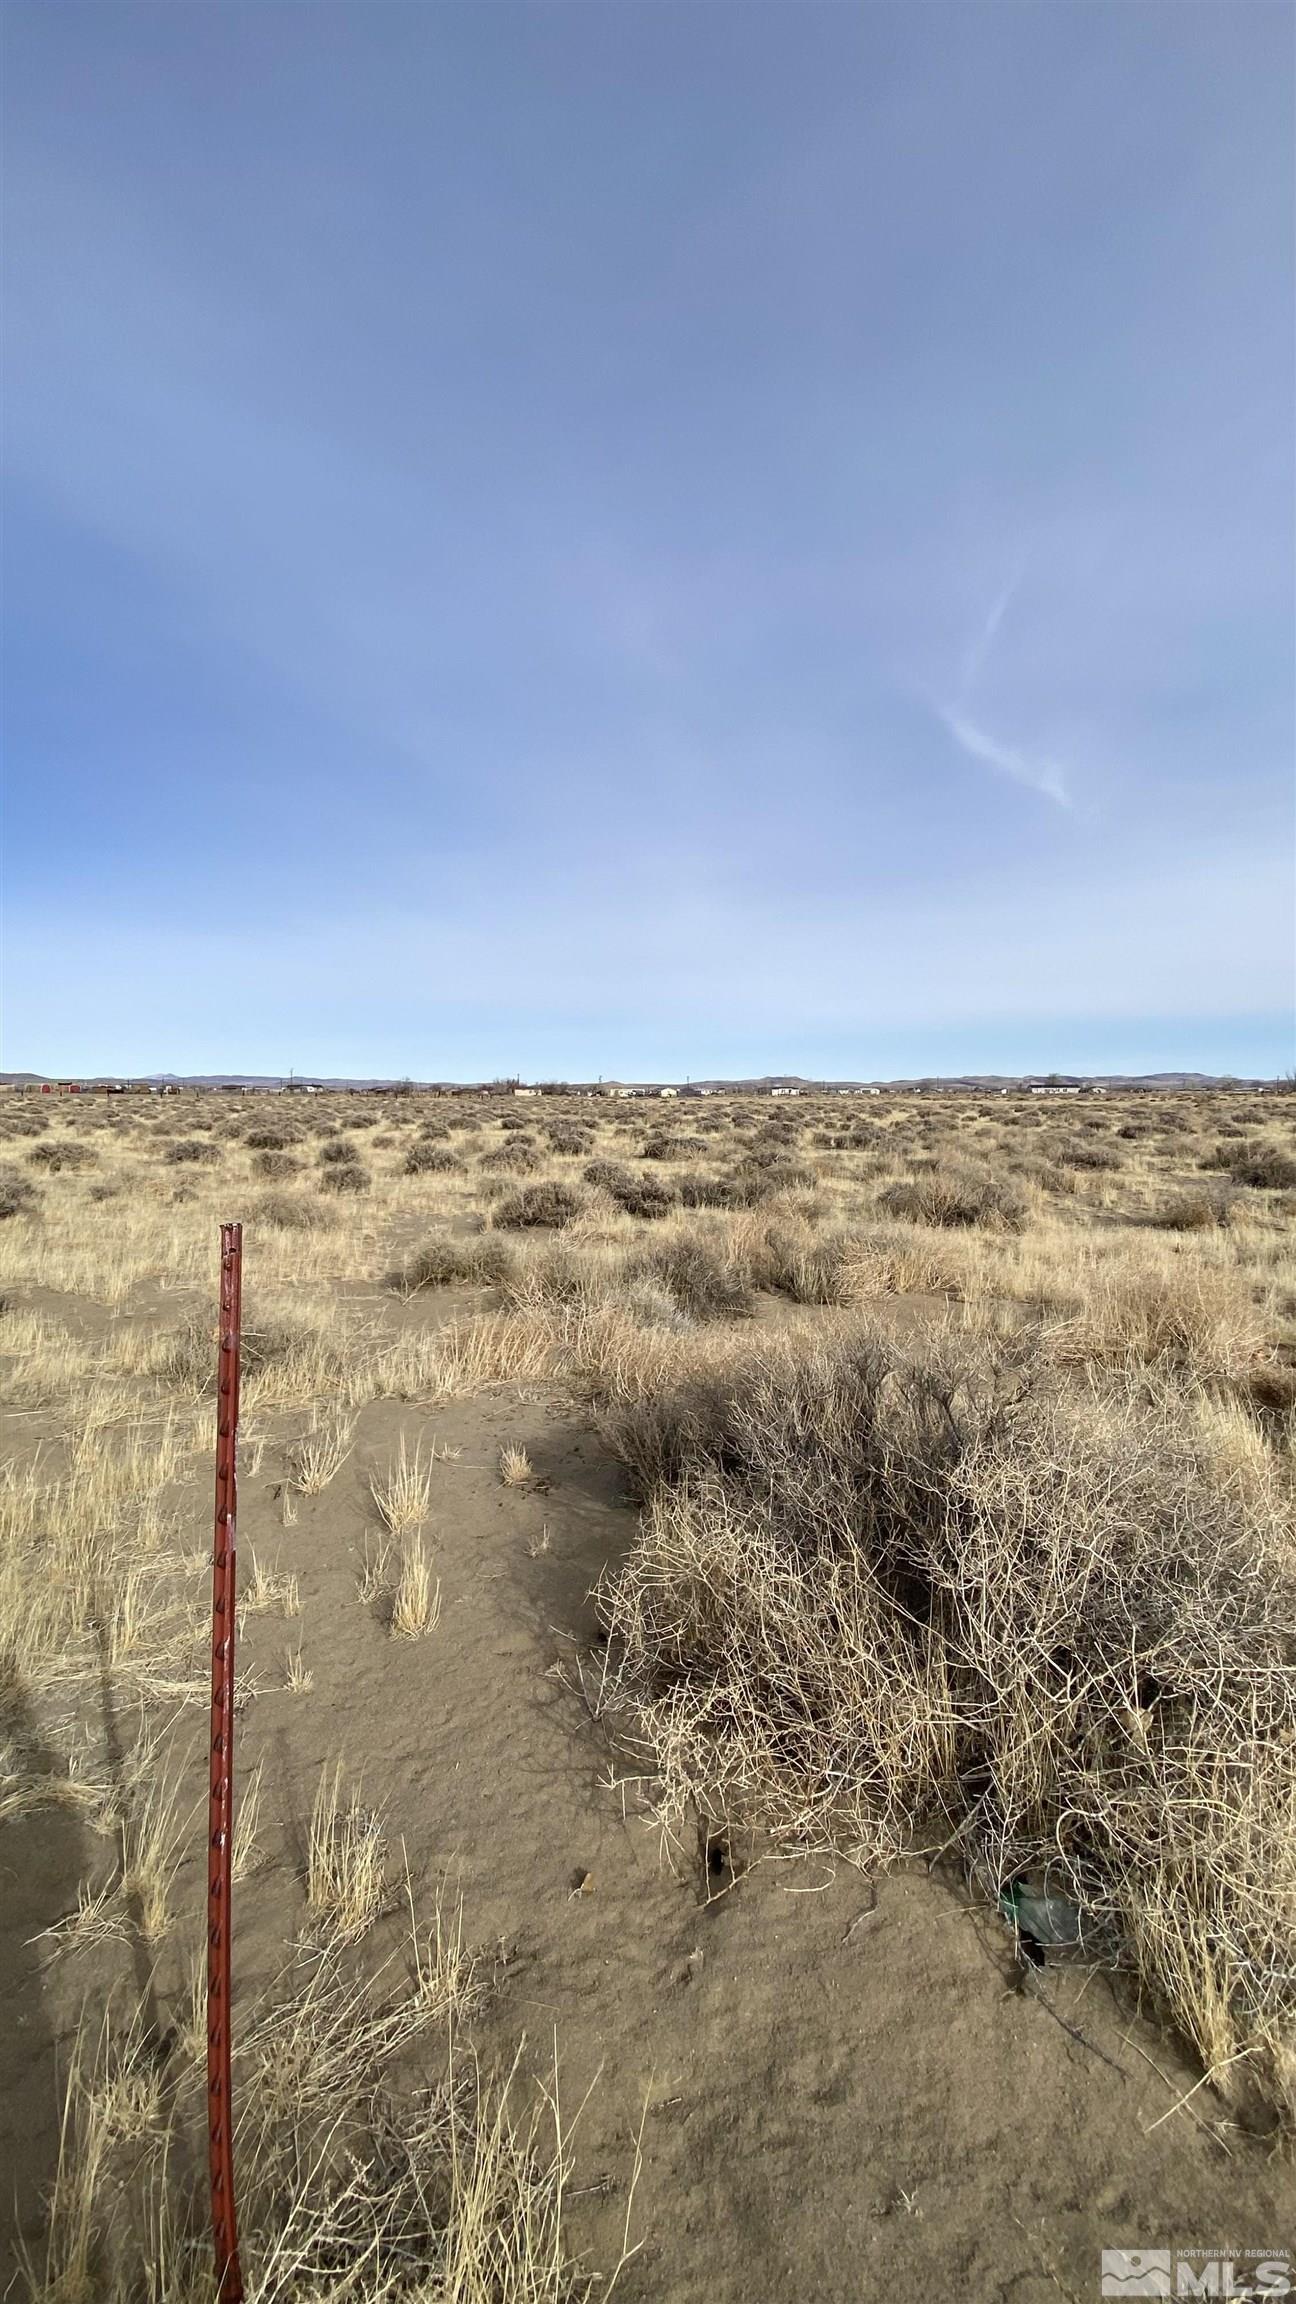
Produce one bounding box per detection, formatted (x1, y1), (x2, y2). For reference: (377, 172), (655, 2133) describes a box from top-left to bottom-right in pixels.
(0, 1073), (1296, 2304)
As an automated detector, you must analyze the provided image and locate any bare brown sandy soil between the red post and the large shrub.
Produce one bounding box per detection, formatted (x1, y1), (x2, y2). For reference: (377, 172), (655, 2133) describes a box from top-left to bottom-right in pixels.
(0, 1354), (1272, 2304)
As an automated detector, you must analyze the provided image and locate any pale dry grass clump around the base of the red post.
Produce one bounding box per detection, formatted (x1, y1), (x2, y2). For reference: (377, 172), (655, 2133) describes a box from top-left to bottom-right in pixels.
(28, 1908), (604, 2304)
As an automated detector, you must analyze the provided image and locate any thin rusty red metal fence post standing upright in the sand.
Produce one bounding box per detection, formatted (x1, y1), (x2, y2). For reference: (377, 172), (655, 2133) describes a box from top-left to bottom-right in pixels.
(208, 1223), (242, 2304)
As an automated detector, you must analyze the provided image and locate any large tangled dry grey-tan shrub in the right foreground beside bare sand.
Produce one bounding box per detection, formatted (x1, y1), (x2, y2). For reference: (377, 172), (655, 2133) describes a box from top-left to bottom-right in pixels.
(602, 1334), (1296, 2108)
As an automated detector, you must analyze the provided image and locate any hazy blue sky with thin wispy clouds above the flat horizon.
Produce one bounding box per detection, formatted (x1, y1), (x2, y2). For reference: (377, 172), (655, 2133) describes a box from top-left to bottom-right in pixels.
(2, 0), (1296, 1078)
